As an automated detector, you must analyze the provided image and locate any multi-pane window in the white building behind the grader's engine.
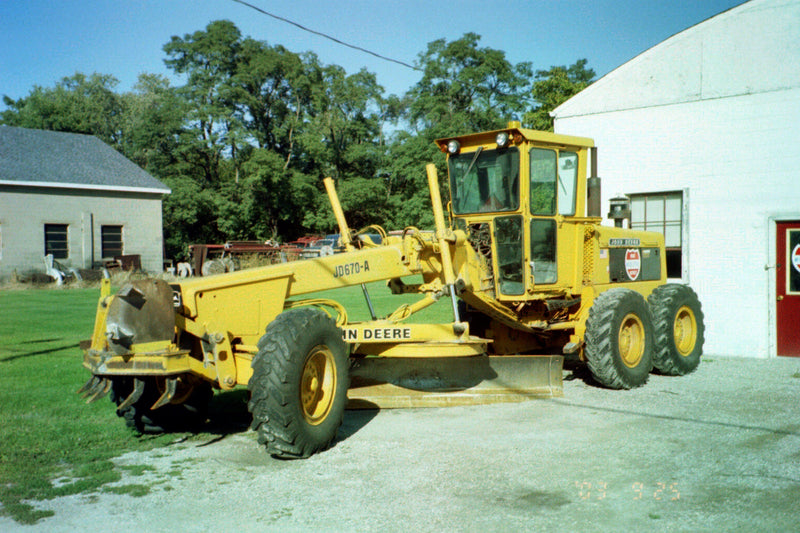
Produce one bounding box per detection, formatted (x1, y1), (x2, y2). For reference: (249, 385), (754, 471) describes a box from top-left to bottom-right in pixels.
(628, 192), (683, 278)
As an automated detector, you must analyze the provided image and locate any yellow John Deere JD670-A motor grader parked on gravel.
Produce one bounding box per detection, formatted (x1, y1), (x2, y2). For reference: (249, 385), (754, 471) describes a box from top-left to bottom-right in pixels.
(81, 122), (703, 457)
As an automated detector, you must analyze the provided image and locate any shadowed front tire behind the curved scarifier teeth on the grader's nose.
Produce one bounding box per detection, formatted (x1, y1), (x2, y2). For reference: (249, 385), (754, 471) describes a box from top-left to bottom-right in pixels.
(110, 378), (214, 433)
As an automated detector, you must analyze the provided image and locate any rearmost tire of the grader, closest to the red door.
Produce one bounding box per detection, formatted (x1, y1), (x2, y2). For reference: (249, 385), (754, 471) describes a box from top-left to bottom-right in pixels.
(647, 283), (705, 376)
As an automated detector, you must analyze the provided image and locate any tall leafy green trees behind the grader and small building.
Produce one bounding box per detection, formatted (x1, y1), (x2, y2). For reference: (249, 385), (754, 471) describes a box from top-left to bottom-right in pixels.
(0, 20), (595, 258)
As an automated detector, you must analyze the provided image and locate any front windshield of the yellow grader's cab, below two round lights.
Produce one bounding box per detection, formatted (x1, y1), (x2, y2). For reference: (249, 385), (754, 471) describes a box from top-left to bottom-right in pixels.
(449, 147), (519, 215)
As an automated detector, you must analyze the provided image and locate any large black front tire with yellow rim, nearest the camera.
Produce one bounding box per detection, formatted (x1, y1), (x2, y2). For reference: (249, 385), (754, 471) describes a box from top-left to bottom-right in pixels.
(247, 308), (350, 459)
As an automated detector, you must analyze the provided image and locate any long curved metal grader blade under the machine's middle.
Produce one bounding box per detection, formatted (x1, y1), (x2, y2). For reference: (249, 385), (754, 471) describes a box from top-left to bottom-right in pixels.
(348, 355), (564, 409)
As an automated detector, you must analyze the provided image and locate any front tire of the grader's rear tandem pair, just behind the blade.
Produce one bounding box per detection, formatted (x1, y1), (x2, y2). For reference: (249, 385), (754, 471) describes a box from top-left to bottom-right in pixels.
(584, 288), (654, 389)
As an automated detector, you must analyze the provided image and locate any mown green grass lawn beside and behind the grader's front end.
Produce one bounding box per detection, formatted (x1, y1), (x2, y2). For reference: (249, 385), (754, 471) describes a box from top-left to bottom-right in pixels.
(0, 281), (452, 524)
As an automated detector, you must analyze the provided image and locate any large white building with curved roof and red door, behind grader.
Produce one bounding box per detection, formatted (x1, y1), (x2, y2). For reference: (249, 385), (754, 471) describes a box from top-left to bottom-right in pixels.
(553, 0), (800, 357)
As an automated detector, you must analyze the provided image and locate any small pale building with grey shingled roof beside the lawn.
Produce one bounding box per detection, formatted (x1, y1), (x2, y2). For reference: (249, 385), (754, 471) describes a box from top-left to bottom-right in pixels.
(0, 126), (170, 279)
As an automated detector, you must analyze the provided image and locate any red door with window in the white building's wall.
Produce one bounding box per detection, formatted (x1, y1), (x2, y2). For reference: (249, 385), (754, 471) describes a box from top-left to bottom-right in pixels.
(775, 222), (800, 357)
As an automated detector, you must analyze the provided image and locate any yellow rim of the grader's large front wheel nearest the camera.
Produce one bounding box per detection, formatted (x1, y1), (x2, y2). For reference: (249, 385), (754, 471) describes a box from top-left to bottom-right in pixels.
(300, 346), (336, 426)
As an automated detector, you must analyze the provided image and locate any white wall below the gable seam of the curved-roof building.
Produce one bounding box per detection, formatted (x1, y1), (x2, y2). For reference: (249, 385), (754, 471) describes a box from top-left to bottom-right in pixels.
(557, 90), (800, 357)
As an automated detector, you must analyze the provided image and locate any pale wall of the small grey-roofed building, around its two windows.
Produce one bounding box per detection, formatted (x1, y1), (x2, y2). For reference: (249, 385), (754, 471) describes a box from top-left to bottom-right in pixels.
(0, 186), (163, 279)
